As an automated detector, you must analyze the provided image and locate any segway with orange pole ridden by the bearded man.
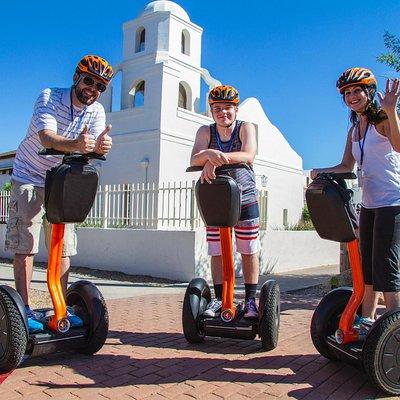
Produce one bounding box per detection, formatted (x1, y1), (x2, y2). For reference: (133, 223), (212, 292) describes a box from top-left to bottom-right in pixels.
(0, 149), (108, 373)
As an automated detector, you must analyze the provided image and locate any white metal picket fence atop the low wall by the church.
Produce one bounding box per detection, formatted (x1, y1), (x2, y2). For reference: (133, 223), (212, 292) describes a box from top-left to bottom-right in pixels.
(0, 181), (268, 230)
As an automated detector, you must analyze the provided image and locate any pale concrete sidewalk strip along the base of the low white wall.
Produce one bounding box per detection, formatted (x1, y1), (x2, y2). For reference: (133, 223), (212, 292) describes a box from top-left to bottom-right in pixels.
(0, 263), (339, 299)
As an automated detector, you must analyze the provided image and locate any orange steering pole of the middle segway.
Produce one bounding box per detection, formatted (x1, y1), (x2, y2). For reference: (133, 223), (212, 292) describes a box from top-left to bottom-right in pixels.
(219, 227), (236, 322)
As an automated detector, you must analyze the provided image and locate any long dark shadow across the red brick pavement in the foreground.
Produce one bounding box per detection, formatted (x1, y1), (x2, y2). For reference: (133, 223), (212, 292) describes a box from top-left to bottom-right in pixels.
(28, 354), (377, 400)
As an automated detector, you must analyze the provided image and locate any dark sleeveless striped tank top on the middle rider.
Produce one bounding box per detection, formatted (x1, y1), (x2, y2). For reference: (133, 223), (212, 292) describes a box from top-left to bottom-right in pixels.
(208, 121), (260, 221)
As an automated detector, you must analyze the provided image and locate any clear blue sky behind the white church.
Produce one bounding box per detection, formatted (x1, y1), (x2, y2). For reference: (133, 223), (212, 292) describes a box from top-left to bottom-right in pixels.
(0, 0), (400, 169)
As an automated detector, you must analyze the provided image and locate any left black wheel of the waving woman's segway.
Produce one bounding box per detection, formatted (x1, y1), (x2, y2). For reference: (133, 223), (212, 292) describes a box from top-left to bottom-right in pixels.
(310, 287), (353, 361)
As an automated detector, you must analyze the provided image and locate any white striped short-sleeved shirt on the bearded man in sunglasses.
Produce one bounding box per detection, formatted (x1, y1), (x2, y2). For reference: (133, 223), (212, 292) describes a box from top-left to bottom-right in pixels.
(12, 88), (106, 187)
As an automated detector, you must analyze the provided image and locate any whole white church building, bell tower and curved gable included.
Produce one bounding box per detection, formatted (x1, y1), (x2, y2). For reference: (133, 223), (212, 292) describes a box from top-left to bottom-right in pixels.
(100, 0), (304, 227)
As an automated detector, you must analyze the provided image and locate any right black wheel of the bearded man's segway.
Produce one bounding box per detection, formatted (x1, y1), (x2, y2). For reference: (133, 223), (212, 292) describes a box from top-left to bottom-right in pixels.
(67, 281), (108, 355)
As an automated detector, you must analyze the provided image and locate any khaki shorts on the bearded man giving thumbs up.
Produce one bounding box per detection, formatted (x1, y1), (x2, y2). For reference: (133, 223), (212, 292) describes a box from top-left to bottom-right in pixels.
(5, 181), (77, 257)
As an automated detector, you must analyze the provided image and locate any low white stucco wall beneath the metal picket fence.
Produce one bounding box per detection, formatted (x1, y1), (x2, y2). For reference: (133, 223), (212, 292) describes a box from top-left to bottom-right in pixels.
(0, 224), (339, 281)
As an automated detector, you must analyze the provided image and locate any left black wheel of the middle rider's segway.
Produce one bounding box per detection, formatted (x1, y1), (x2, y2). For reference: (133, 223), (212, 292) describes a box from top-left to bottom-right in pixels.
(182, 278), (211, 343)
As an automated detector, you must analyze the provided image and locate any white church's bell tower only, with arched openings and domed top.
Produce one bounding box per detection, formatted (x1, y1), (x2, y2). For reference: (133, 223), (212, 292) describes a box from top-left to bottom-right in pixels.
(101, 0), (209, 183)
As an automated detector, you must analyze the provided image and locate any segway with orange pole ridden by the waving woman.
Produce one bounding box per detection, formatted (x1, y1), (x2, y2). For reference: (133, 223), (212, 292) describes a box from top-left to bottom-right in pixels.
(306, 173), (400, 395)
